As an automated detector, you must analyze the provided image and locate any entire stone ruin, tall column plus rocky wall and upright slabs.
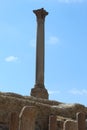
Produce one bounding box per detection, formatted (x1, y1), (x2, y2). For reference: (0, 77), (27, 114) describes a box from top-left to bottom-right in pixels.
(0, 8), (87, 130)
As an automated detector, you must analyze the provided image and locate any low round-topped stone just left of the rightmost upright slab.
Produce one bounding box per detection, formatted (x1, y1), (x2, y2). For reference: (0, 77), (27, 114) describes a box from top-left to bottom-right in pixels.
(63, 120), (78, 130)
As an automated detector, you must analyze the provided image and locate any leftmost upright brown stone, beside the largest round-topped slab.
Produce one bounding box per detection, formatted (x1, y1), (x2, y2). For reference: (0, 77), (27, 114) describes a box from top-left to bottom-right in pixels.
(9, 112), (19, 130)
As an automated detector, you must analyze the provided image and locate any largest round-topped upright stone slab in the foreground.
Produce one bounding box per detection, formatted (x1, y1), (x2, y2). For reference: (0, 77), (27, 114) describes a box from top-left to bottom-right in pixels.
(19, 106), (36, 130)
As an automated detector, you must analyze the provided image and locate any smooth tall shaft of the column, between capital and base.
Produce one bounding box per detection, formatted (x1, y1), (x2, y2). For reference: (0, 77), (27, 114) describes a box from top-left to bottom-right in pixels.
(36, 19), (44, 86)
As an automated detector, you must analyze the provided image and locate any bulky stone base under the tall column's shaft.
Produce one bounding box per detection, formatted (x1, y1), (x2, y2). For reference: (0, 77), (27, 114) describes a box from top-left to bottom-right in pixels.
(31, 85), (49, 99)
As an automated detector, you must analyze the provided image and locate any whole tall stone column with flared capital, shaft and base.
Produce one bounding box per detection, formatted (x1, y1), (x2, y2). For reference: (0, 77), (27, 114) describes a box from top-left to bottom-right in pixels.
(31, 8), (48, 99)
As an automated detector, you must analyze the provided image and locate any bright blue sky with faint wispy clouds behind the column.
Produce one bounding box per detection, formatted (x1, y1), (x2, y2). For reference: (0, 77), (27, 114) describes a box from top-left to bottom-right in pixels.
(0, 0), (87, 106)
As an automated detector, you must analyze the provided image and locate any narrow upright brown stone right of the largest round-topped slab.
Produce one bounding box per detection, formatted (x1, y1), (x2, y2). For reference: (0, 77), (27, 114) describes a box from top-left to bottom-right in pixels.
(49, 115), (57, 130)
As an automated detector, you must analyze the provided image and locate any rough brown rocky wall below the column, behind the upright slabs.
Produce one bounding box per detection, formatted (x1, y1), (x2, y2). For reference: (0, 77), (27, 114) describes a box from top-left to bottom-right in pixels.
(0, 93), (87, 130)
